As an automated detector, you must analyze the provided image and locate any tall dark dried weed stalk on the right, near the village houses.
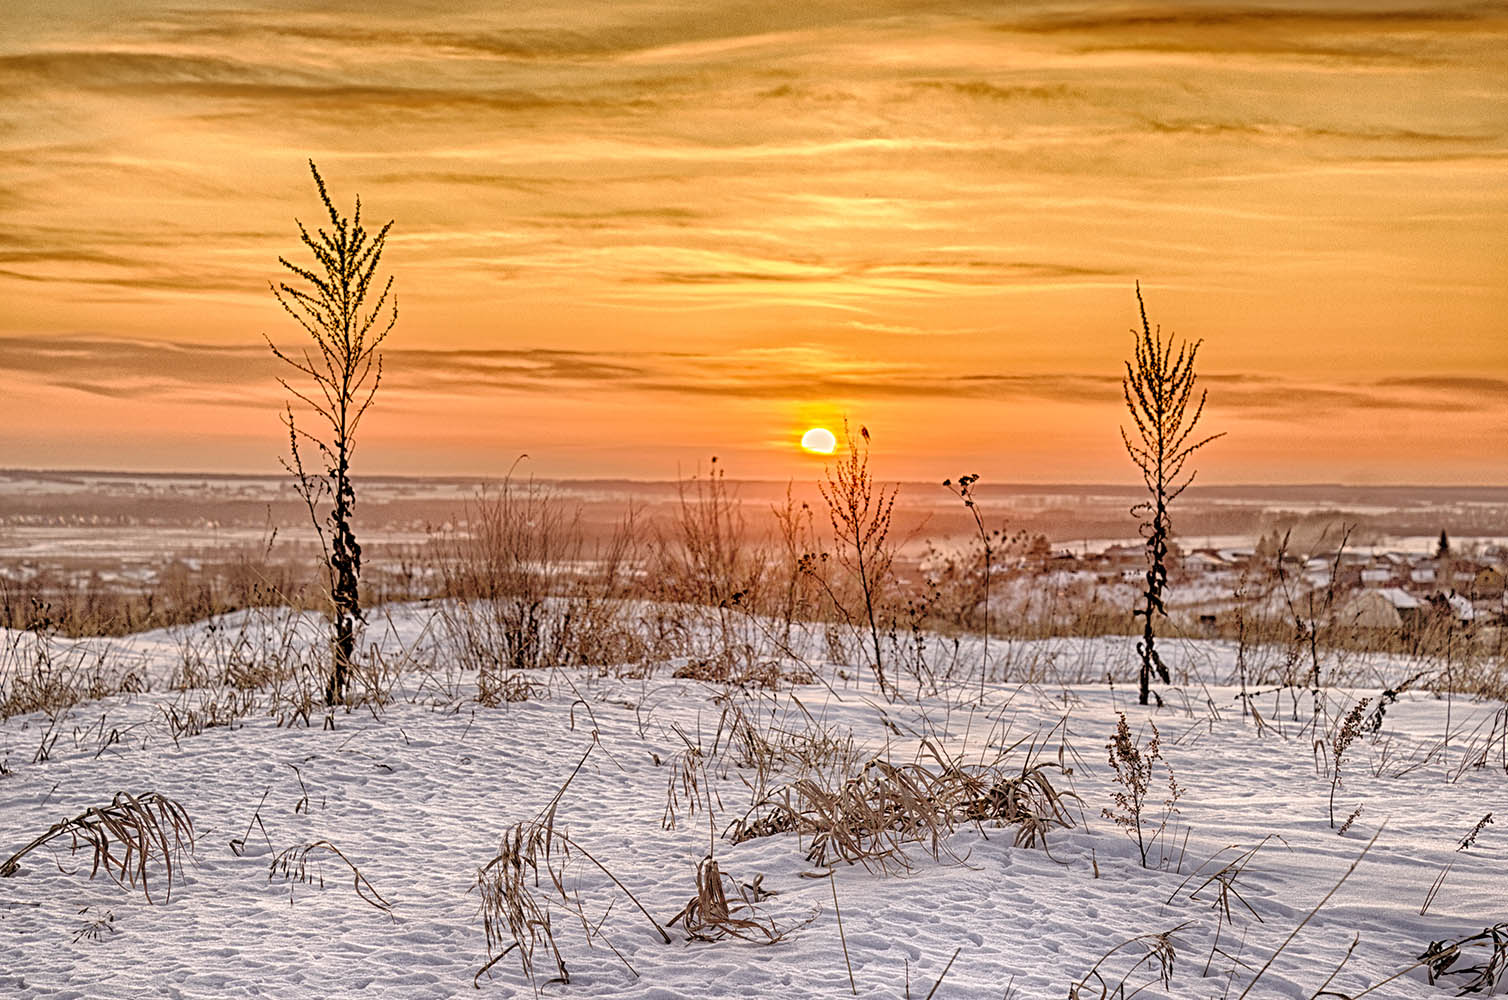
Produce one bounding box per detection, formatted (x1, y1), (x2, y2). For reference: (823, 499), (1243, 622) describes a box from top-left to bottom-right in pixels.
(1120, 282), (1221, 704)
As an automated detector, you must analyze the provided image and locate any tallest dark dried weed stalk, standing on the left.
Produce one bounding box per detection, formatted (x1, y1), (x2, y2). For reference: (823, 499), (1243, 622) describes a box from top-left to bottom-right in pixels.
(267, 160), (398, 706)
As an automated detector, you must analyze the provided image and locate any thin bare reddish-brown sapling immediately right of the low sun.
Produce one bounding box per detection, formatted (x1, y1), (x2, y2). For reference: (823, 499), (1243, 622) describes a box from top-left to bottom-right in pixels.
(817, 421), (896, 697)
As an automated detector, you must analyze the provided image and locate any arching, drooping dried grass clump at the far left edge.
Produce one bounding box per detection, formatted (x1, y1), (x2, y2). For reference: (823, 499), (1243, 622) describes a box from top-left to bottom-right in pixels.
(0, 792), (195, 902)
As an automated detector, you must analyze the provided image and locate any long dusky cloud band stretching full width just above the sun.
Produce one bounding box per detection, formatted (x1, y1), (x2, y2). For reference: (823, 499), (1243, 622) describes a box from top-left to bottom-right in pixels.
(0, 335), (1508, 422)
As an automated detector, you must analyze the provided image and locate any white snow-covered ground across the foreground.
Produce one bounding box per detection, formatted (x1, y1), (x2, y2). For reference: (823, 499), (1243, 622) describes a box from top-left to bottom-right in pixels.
(0, 606), (1508, 1000)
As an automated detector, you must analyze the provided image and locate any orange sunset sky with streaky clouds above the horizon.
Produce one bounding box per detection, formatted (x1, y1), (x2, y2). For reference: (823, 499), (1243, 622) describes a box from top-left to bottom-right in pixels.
(0, 0), (1508, 484)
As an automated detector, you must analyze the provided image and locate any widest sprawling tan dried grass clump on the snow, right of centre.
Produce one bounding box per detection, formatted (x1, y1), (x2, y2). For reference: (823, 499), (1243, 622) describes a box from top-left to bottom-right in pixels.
(725, 741), (1077, 870)
